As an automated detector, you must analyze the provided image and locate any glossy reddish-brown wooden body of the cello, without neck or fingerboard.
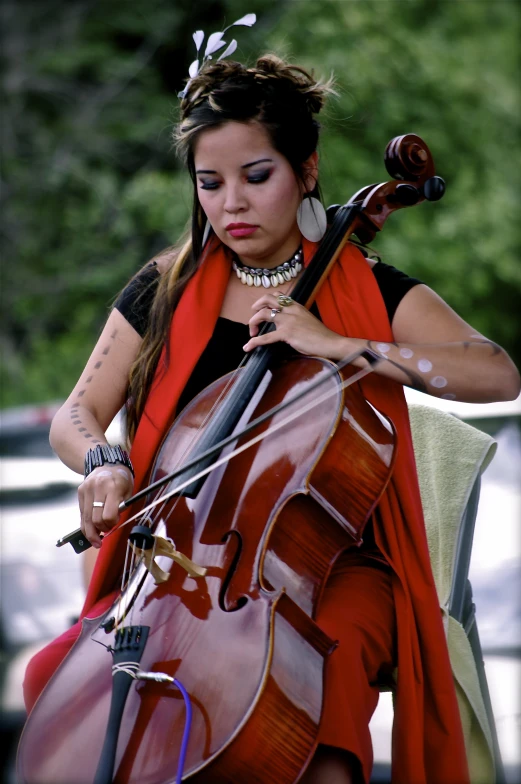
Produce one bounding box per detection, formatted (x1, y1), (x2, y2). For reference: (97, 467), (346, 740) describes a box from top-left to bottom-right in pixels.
(18, 358), (394, 784)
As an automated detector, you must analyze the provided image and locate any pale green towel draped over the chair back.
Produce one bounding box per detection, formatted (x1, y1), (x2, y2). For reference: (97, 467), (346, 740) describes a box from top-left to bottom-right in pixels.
(409, 404), (497, 784)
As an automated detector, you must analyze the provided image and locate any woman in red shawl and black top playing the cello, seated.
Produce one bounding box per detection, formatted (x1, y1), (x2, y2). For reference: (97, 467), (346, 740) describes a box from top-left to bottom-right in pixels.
(25, 50), (520, 784)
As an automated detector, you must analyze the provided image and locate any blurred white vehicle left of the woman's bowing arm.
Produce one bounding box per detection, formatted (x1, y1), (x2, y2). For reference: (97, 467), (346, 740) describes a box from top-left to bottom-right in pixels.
(0, 404), (122, 784)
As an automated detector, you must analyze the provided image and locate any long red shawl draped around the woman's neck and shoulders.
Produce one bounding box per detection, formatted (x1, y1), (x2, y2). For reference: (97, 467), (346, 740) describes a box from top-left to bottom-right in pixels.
(83, 241), (468, 784)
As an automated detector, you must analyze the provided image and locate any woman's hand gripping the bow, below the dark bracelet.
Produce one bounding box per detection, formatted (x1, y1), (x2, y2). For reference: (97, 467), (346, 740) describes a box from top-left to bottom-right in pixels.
(78, 463), (134, 549)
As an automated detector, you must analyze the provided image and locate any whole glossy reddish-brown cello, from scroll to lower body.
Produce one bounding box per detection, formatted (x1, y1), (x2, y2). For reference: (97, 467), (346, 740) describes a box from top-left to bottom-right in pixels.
(17, 134), (444, 784)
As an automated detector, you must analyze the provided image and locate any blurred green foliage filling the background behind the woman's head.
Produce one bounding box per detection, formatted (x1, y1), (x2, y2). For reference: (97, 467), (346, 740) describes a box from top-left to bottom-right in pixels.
(0, 0), (521, 406)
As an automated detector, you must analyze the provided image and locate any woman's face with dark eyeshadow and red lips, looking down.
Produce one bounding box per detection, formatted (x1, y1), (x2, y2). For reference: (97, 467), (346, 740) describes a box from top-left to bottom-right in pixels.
(194, 122), (310, 267)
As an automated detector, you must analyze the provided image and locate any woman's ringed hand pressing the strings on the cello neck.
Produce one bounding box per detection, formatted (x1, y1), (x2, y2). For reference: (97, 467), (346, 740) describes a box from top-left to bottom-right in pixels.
(243, 292), (350, 360)
